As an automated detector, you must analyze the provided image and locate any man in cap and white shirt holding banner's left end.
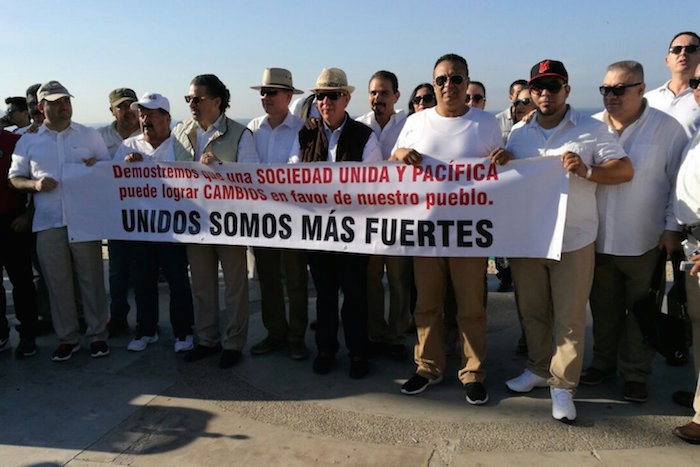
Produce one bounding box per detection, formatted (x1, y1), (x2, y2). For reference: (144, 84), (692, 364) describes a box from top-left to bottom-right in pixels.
(8, 81), (111, 362)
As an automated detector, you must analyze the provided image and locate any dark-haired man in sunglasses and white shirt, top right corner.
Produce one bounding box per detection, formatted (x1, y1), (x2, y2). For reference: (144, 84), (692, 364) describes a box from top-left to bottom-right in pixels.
(644, 31), (700, 138)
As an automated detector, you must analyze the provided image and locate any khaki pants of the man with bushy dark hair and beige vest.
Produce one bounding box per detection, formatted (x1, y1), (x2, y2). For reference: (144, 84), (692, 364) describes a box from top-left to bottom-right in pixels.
(187, 244), (249, 350)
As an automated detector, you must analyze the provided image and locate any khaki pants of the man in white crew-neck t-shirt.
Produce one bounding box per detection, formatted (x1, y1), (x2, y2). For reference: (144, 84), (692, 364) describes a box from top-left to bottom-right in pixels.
(413, 257), (487, 384)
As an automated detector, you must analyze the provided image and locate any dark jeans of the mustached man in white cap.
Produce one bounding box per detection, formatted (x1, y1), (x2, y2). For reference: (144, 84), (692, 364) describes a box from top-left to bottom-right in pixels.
(129, 242), (194, 337)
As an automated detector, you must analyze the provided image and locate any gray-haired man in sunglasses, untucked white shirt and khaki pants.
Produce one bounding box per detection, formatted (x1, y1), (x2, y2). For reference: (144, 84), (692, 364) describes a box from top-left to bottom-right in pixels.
(580, 60), (688, 402)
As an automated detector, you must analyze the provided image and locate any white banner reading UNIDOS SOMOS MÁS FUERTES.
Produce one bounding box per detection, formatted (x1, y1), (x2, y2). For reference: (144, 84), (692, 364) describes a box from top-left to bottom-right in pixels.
(63, 157), (568, 259)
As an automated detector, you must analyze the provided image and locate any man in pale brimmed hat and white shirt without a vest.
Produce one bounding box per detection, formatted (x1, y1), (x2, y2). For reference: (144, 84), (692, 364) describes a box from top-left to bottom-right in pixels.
(248, 68), (309, 360)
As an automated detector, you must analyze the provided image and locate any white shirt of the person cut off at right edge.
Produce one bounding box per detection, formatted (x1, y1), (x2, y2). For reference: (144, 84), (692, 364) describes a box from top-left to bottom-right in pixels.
(675, 131), (700, 225)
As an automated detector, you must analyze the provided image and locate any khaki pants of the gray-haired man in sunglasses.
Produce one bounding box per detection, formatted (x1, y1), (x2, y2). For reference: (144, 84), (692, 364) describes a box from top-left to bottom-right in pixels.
(590, 248), (665, 383)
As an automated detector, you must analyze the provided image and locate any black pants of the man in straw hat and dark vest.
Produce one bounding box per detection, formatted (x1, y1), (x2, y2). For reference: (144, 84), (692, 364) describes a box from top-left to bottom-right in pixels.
(308, 252), (368, 358)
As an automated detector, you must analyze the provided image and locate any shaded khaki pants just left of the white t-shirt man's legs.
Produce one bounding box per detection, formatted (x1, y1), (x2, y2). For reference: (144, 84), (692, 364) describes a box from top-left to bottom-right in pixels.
(367, 255), (413, 344)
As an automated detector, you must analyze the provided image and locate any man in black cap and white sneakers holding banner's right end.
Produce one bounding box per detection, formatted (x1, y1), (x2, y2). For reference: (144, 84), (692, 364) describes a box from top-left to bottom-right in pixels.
(506, 60), (634, 421)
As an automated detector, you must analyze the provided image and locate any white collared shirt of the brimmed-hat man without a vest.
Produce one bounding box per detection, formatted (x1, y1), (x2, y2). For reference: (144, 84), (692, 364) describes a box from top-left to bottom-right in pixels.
(248, 113), (304, 164)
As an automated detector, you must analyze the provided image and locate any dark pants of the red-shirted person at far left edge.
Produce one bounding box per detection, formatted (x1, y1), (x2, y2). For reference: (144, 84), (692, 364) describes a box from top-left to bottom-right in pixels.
(0, 215), (38, 339)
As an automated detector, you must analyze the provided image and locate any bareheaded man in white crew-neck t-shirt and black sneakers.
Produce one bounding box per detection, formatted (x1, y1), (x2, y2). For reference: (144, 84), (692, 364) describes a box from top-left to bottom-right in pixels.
(391, 54), (509, 405)
